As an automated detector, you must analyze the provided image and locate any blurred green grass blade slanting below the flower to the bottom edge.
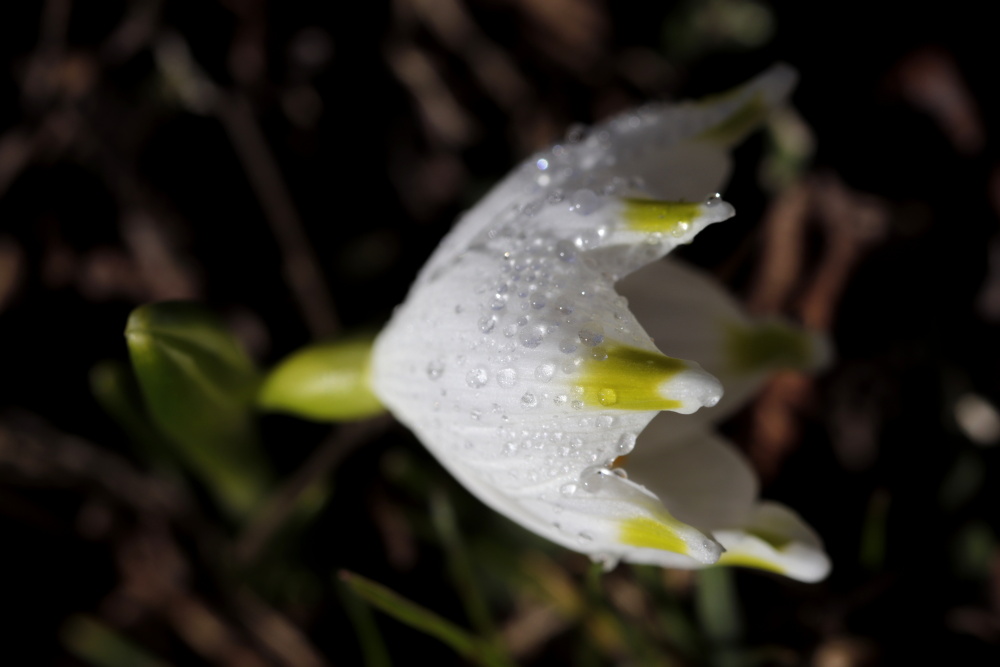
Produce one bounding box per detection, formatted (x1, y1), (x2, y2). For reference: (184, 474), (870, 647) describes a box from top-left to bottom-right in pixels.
(340, 570), (509, 667)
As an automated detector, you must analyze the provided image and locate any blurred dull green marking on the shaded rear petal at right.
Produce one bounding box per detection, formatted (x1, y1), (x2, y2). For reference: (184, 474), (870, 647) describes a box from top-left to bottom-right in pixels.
(725, 322), (814, 373)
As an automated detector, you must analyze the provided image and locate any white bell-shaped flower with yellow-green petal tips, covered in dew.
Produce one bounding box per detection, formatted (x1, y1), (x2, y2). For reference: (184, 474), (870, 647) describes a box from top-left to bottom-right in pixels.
(371, 66), (825, 579)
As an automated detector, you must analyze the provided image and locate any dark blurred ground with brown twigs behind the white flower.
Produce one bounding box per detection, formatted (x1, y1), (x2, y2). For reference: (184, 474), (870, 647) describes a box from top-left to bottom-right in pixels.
(0, 0), (1000, 665)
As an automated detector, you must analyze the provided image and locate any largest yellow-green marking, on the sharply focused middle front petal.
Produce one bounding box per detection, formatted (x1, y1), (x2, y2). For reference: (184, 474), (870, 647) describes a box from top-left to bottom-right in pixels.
(576, 343), (688, 410)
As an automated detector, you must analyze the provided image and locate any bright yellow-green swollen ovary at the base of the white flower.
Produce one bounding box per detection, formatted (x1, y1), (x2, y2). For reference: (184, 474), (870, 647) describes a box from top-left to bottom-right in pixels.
(257, 339), (385, 422)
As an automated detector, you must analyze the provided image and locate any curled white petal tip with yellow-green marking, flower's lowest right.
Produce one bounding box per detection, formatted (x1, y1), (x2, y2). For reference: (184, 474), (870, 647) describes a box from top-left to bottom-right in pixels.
(714, 502), (830, 582)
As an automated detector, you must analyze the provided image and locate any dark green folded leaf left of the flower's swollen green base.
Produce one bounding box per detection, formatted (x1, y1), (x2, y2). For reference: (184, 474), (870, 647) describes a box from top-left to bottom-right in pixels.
(125, 301), (269, 514)
